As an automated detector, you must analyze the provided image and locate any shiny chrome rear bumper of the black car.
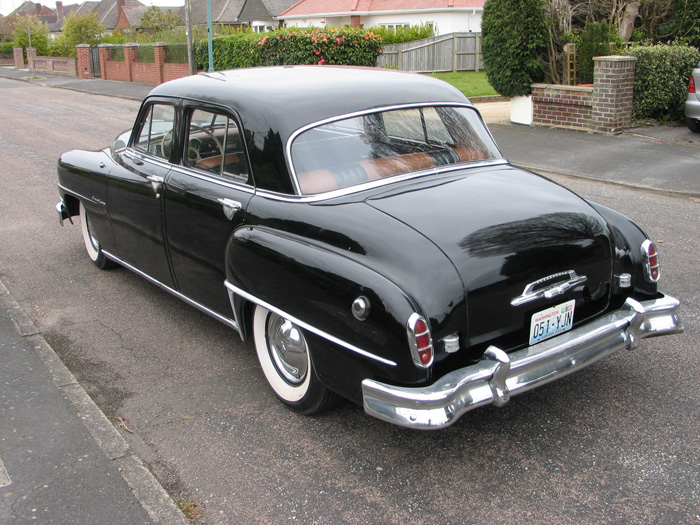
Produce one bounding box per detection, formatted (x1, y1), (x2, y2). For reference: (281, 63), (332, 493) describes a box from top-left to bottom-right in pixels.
(362, 296), (683, 430)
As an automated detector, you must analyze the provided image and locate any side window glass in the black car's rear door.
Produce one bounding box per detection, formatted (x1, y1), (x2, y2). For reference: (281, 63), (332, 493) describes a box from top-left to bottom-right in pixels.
(184, 109), (249, 183)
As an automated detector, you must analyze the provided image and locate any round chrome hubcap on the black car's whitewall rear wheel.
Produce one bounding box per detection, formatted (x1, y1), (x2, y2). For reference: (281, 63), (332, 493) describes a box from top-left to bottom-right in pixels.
(267, 313), (309, 385)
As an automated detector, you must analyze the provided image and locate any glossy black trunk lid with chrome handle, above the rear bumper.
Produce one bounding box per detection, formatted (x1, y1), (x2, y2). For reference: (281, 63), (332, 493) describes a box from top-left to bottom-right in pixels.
(367, 166), (612, 351)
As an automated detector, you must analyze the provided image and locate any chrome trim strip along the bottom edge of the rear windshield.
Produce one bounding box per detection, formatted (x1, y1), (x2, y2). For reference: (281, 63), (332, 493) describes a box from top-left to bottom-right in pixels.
(256, 158), (508, 203)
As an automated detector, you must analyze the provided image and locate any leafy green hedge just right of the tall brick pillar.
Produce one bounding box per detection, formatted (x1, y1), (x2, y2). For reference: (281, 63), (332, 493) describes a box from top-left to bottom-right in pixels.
(624, 44), (700, 121)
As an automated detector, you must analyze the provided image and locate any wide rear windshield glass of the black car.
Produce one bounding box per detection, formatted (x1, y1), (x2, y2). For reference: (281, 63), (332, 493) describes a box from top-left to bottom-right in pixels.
(291, 106), (501, 195)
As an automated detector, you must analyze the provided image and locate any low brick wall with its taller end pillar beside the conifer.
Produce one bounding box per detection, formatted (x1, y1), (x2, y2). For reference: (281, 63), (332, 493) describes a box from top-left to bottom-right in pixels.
(532, 56), (637, 134)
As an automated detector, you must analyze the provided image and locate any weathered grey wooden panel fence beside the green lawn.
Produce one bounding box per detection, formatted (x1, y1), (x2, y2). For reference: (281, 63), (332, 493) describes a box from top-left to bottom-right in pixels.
(377, 33), (484, 73)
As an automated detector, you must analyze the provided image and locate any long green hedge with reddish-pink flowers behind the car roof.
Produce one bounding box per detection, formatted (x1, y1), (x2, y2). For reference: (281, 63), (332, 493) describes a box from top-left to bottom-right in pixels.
(195, 28), (381, 70)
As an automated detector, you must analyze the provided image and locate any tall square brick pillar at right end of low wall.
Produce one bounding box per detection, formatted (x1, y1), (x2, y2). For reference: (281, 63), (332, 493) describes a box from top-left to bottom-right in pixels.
(591, 56), (637, 134)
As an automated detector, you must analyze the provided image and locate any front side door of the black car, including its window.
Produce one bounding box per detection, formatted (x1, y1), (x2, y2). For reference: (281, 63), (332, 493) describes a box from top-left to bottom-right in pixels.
(107, 99), (177, 288)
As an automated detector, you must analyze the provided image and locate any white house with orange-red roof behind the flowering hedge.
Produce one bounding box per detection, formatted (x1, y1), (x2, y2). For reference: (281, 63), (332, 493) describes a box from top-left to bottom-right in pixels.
(277, 0), (485, 34)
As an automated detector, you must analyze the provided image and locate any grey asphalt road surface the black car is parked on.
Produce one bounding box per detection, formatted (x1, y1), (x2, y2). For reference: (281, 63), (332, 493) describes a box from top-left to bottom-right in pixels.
(0, 79), (700, 524)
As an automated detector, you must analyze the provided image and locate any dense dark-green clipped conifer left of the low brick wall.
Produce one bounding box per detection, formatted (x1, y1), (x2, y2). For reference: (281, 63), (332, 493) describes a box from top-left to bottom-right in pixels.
(481, 0), (549, 97)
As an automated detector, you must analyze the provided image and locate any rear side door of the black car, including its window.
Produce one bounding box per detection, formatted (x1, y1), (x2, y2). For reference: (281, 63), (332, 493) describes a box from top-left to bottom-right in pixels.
(164, 102), (254, 319)
